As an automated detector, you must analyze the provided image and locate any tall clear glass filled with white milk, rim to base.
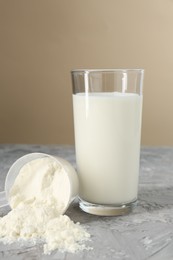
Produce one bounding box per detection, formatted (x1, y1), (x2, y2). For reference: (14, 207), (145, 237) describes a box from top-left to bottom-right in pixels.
(72, 69), (144, 216)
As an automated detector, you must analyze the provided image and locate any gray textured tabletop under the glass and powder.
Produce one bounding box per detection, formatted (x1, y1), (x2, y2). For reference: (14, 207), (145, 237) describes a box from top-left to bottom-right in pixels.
(0, 145), (173, 260)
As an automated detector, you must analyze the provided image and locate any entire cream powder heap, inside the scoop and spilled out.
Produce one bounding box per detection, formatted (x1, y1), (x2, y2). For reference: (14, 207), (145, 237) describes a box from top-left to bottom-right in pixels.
(0, 157), (90, 254)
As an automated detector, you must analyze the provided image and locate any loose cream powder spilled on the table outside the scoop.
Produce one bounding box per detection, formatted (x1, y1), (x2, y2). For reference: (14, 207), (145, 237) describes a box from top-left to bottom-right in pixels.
(0, 204), (90, 254)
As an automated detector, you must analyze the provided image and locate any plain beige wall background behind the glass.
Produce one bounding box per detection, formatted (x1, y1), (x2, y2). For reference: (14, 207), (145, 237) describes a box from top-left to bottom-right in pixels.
(0, 0), (173, 145)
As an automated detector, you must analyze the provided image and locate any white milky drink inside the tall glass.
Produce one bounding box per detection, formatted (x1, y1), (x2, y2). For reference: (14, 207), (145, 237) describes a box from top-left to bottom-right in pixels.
(73, 92), (142, 205)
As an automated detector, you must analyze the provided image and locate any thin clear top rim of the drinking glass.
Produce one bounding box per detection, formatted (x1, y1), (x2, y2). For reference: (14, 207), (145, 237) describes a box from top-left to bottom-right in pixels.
(71, 68), (144, 74)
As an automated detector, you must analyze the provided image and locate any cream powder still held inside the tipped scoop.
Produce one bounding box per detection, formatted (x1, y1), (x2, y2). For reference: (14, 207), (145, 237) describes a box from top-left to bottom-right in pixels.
(9, 157), (70, 213)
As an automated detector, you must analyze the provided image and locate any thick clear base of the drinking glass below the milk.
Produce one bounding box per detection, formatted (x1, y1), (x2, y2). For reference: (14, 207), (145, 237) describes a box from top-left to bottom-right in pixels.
(79, 198), (137, 216)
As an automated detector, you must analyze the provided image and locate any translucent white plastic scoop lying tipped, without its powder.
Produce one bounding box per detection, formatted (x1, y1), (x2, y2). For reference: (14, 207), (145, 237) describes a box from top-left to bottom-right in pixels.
(0, 153), (79, 211)
